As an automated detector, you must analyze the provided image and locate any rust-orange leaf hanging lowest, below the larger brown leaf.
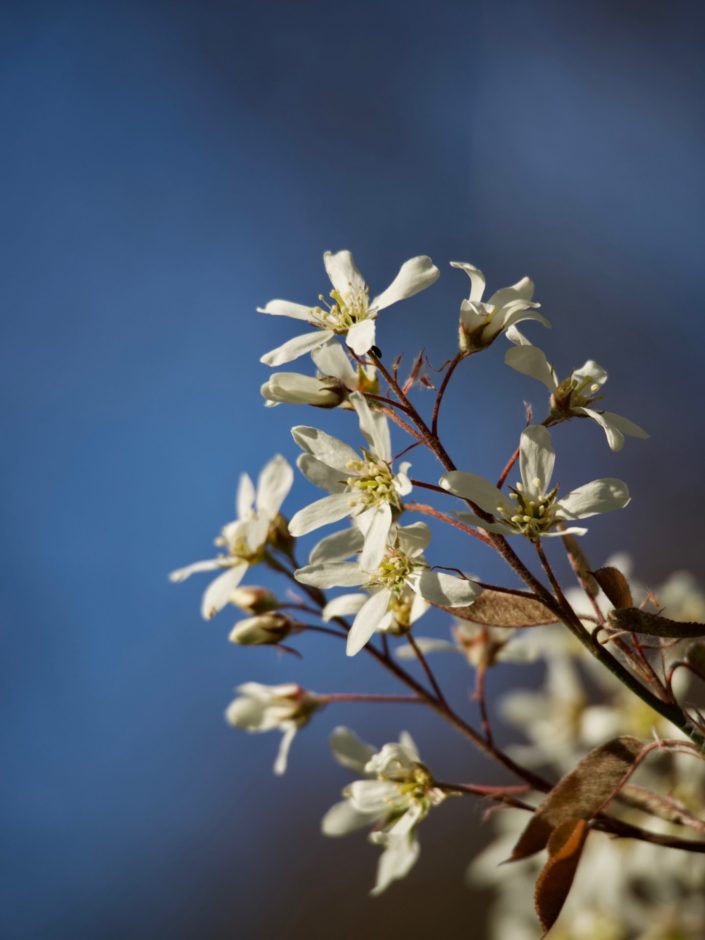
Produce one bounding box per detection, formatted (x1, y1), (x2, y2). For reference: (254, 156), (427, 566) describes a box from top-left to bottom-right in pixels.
(534, 819), (590, 936)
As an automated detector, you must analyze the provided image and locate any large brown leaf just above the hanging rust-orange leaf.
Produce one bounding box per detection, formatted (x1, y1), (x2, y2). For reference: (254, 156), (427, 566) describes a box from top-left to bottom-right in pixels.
(508, 735), (644, 862)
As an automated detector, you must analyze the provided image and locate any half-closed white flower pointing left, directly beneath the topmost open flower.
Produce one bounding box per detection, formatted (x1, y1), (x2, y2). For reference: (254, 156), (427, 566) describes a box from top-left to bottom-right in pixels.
(260, 343), (378, 408)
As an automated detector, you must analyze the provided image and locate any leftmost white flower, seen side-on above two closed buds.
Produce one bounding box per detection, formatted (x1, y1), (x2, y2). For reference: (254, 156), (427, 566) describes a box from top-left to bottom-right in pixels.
(169, 455), (294, 620)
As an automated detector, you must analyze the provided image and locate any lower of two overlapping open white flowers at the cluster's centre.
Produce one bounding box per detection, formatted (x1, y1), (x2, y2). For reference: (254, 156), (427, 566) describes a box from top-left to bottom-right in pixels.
(296, 522), (480, 656)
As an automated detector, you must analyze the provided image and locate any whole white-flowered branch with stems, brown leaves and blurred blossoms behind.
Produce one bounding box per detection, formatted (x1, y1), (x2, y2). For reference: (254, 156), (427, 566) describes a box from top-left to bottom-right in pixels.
(170, 244), (705, 940)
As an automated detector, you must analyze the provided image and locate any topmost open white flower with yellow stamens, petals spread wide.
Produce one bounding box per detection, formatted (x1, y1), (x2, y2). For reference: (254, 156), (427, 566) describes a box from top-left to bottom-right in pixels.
(257, 251), (440, 366)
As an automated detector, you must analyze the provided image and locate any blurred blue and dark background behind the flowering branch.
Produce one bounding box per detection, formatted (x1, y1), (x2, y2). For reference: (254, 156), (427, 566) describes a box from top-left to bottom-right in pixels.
(0, 0), (705, 940)
